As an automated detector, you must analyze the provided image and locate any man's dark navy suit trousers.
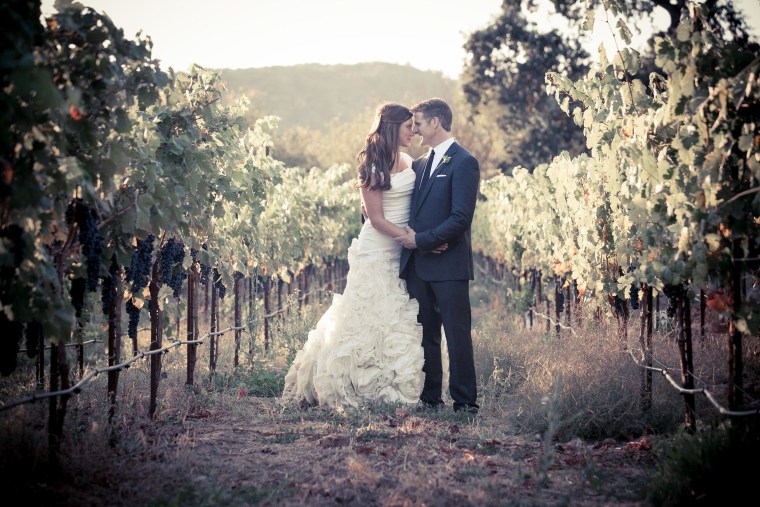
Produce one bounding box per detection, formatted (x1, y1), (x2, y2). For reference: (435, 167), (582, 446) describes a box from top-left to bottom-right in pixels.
(406, 252), (478, 409)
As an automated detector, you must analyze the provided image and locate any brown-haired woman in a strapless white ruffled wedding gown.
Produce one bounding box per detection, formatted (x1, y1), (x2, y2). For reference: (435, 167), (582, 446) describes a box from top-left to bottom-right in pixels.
(282, 103), (436, 408)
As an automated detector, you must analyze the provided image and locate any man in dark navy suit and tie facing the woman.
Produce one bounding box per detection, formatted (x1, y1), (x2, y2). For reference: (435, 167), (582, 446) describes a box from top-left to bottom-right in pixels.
(395, 98), (480, 414)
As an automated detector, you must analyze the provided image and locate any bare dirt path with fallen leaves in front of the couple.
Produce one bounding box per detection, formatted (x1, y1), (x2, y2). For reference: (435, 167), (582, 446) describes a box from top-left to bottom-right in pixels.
(49, 396), (654, 506)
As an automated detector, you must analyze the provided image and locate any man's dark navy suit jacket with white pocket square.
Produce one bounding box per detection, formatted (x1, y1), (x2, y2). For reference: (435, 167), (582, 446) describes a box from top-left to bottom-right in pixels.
(399, 142), (480, 282)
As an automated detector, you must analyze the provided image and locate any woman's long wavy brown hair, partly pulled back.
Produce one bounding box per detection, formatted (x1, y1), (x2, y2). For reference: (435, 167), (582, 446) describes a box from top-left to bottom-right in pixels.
(356, 102), (414, 190)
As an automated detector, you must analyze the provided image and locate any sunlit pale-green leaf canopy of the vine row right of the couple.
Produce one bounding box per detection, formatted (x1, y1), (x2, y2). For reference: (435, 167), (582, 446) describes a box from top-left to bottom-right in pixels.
(473, 4), (760, 333)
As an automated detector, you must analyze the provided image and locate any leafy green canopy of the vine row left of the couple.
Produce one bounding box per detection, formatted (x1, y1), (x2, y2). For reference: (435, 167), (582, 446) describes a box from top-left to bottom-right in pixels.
(0, 1), (368, 374)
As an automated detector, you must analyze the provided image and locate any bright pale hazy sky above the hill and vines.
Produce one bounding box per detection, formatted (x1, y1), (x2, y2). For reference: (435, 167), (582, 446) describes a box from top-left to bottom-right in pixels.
(42, 0), (760, 78)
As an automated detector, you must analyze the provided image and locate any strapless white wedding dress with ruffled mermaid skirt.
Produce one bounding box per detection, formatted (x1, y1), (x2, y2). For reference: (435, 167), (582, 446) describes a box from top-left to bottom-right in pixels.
(282, 161), (424, 408)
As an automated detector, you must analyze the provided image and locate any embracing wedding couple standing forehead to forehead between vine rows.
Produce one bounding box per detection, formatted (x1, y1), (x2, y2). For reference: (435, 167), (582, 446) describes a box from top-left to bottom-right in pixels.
(282, 98), (480, 414)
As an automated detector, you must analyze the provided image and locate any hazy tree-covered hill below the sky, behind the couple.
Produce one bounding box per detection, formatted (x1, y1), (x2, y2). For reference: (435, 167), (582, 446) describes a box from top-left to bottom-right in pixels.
(217, 62), (456, 130)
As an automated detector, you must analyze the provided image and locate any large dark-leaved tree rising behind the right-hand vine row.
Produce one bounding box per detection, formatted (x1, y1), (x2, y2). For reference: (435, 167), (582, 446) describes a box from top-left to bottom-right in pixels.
(462, 0), (588, 173)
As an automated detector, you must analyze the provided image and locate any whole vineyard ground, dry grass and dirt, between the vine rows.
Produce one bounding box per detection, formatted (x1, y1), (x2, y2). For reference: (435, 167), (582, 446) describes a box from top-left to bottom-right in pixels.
(0, 285), (757, 506)
